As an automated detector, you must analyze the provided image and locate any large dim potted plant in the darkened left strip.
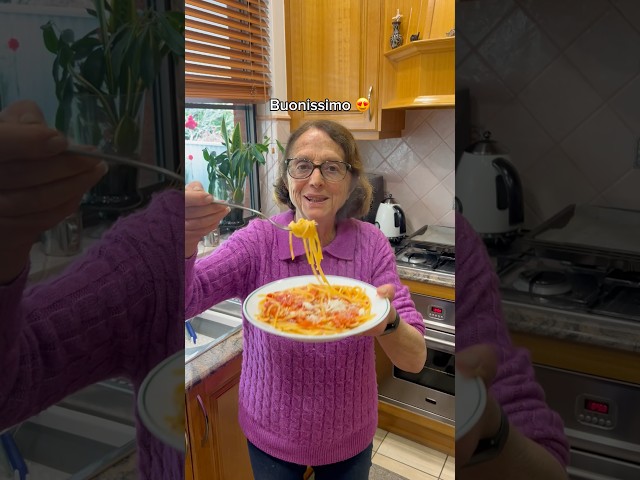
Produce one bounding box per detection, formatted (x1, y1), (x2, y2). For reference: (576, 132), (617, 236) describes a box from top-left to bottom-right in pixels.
(42, 0), (184, 210)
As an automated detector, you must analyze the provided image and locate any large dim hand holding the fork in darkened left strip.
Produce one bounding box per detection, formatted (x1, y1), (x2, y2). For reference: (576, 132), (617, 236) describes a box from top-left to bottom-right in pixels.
(0, 101), (107, 284)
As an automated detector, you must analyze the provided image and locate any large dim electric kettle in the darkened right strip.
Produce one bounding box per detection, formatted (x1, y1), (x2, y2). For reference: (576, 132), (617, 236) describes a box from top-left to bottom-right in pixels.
(455, 132), (524, 239)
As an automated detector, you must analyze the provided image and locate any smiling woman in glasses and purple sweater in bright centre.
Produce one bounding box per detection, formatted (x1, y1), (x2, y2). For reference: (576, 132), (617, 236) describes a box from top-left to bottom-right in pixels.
(185, 121), (426, 480)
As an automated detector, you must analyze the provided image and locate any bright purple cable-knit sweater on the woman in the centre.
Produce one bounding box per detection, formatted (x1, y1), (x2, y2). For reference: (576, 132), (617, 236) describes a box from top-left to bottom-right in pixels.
(185, 211), (423, 465)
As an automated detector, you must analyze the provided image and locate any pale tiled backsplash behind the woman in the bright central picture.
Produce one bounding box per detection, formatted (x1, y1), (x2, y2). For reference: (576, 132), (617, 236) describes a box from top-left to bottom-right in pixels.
(259, 109), (455, 232)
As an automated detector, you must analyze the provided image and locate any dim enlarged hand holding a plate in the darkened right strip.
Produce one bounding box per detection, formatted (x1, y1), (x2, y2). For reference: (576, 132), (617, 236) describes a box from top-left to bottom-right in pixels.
(456, 345), (501, 467)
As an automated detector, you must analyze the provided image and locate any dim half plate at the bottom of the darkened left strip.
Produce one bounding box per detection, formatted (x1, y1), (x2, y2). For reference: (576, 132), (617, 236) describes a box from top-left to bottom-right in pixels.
(138, 350), (185, 452)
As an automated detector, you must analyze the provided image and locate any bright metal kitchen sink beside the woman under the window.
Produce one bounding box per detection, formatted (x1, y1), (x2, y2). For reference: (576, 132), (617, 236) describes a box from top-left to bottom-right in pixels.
(184, 300), (242, 362)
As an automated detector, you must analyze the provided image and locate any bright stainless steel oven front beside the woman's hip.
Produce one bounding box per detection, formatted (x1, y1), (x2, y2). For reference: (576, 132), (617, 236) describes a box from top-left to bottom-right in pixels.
(378, 294), (455, 425)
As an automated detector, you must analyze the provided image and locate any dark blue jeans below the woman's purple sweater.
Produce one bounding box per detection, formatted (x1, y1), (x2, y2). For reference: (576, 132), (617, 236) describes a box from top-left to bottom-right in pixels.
(247, 442), (373, 480)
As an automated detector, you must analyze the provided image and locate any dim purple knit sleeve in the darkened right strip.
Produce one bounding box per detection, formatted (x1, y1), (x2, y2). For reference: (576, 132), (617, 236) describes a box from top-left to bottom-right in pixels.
(456, 215), (569, 465)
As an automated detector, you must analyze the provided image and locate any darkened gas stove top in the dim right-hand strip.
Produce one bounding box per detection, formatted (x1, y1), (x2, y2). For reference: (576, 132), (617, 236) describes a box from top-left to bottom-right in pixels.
(497, 249), (640, 322)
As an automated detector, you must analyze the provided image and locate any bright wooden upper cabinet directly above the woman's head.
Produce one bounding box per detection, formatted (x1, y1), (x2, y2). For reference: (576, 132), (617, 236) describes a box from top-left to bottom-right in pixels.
(285, 0), (404, 140)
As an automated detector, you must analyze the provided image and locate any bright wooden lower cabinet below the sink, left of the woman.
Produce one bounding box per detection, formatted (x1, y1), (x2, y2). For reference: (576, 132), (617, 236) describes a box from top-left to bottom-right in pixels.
(185, 356), (253, 480)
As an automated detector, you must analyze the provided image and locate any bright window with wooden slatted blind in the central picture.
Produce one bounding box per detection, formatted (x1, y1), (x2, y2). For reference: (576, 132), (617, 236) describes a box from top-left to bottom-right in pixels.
(185, 0), (270, 209)
